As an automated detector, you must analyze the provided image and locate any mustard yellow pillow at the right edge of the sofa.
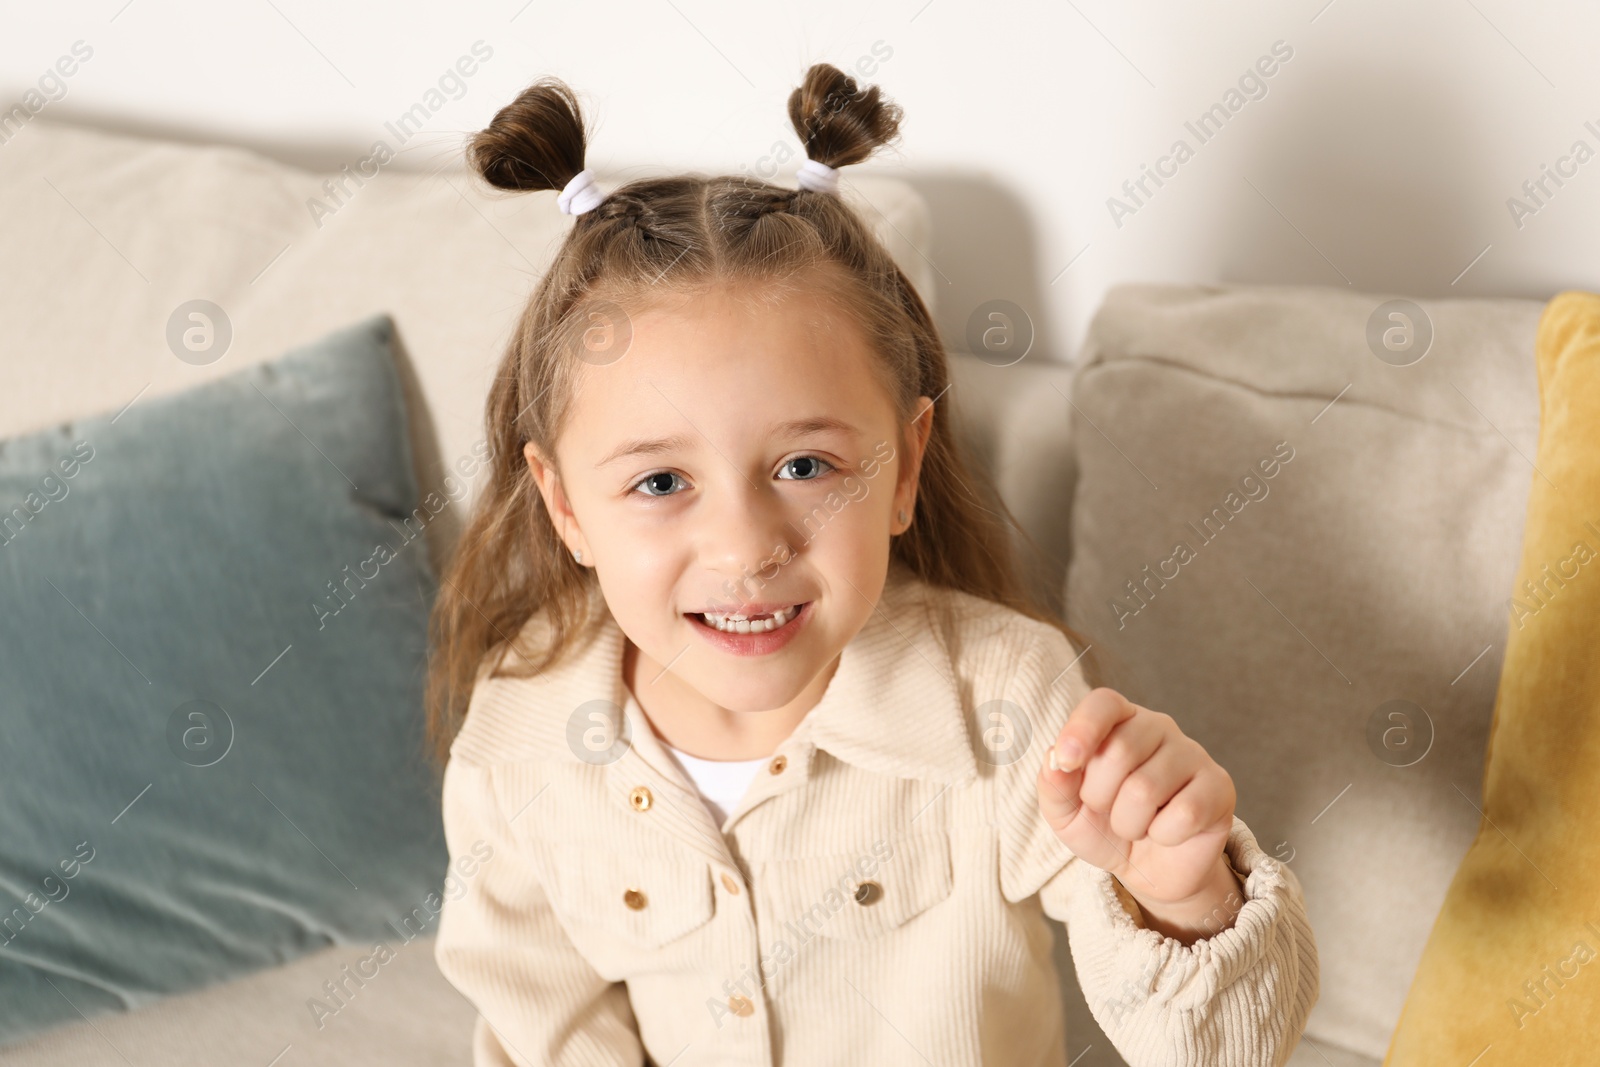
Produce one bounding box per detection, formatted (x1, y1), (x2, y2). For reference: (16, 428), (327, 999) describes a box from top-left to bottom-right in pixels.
(1374, 291), (1600, 1067)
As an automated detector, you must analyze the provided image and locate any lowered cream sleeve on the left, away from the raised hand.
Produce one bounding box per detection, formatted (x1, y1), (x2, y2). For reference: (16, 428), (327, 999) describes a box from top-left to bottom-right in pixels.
(434, 758), (645, 1067)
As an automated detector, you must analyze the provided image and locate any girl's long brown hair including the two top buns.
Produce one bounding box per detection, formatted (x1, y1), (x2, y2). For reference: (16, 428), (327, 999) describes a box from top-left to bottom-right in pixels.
(427, 64), (1093, 765)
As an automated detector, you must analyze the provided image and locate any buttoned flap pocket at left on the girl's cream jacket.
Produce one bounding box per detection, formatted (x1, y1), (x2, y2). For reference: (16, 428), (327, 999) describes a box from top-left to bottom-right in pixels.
(549, 843), (714, 952)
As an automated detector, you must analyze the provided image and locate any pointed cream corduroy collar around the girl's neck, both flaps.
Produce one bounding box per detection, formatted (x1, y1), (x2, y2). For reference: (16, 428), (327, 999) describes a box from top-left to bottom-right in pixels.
(504, 561), (978, 784)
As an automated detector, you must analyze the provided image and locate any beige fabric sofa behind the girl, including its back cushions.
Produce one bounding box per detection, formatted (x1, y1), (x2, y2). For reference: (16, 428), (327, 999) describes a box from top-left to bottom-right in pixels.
(0, 118), (1541, 1067)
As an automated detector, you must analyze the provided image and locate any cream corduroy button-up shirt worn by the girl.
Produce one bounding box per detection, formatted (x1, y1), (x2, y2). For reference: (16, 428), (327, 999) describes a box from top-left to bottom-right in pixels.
(435, 565), (1318, 1067)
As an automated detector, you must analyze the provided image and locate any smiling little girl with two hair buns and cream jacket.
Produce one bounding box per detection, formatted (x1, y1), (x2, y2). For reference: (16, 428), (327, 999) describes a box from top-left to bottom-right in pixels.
(429, 64), (1318, 1067)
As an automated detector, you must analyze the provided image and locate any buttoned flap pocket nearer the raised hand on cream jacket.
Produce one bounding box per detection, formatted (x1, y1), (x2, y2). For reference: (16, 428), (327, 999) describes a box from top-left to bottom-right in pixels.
(757, 830), (954, 941)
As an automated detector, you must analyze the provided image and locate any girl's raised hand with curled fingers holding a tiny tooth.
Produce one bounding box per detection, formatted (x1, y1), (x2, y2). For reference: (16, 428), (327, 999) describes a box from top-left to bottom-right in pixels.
(1038, 686), (1243, 944)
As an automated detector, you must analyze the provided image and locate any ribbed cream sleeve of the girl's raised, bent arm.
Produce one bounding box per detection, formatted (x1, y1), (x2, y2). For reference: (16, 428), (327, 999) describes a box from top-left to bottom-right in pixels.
(1000, 637), (1320, 1067)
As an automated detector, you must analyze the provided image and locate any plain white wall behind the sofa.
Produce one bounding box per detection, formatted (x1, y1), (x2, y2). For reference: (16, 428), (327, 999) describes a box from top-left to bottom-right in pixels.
(0, 0), (1600, 367)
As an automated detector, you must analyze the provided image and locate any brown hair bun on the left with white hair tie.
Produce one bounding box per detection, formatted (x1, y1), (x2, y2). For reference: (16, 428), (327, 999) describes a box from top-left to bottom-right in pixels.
(467, 78), (586, 192)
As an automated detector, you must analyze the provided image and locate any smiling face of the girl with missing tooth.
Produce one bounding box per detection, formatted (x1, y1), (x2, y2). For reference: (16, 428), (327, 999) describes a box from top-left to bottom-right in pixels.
(525, 288), (933, 712)
